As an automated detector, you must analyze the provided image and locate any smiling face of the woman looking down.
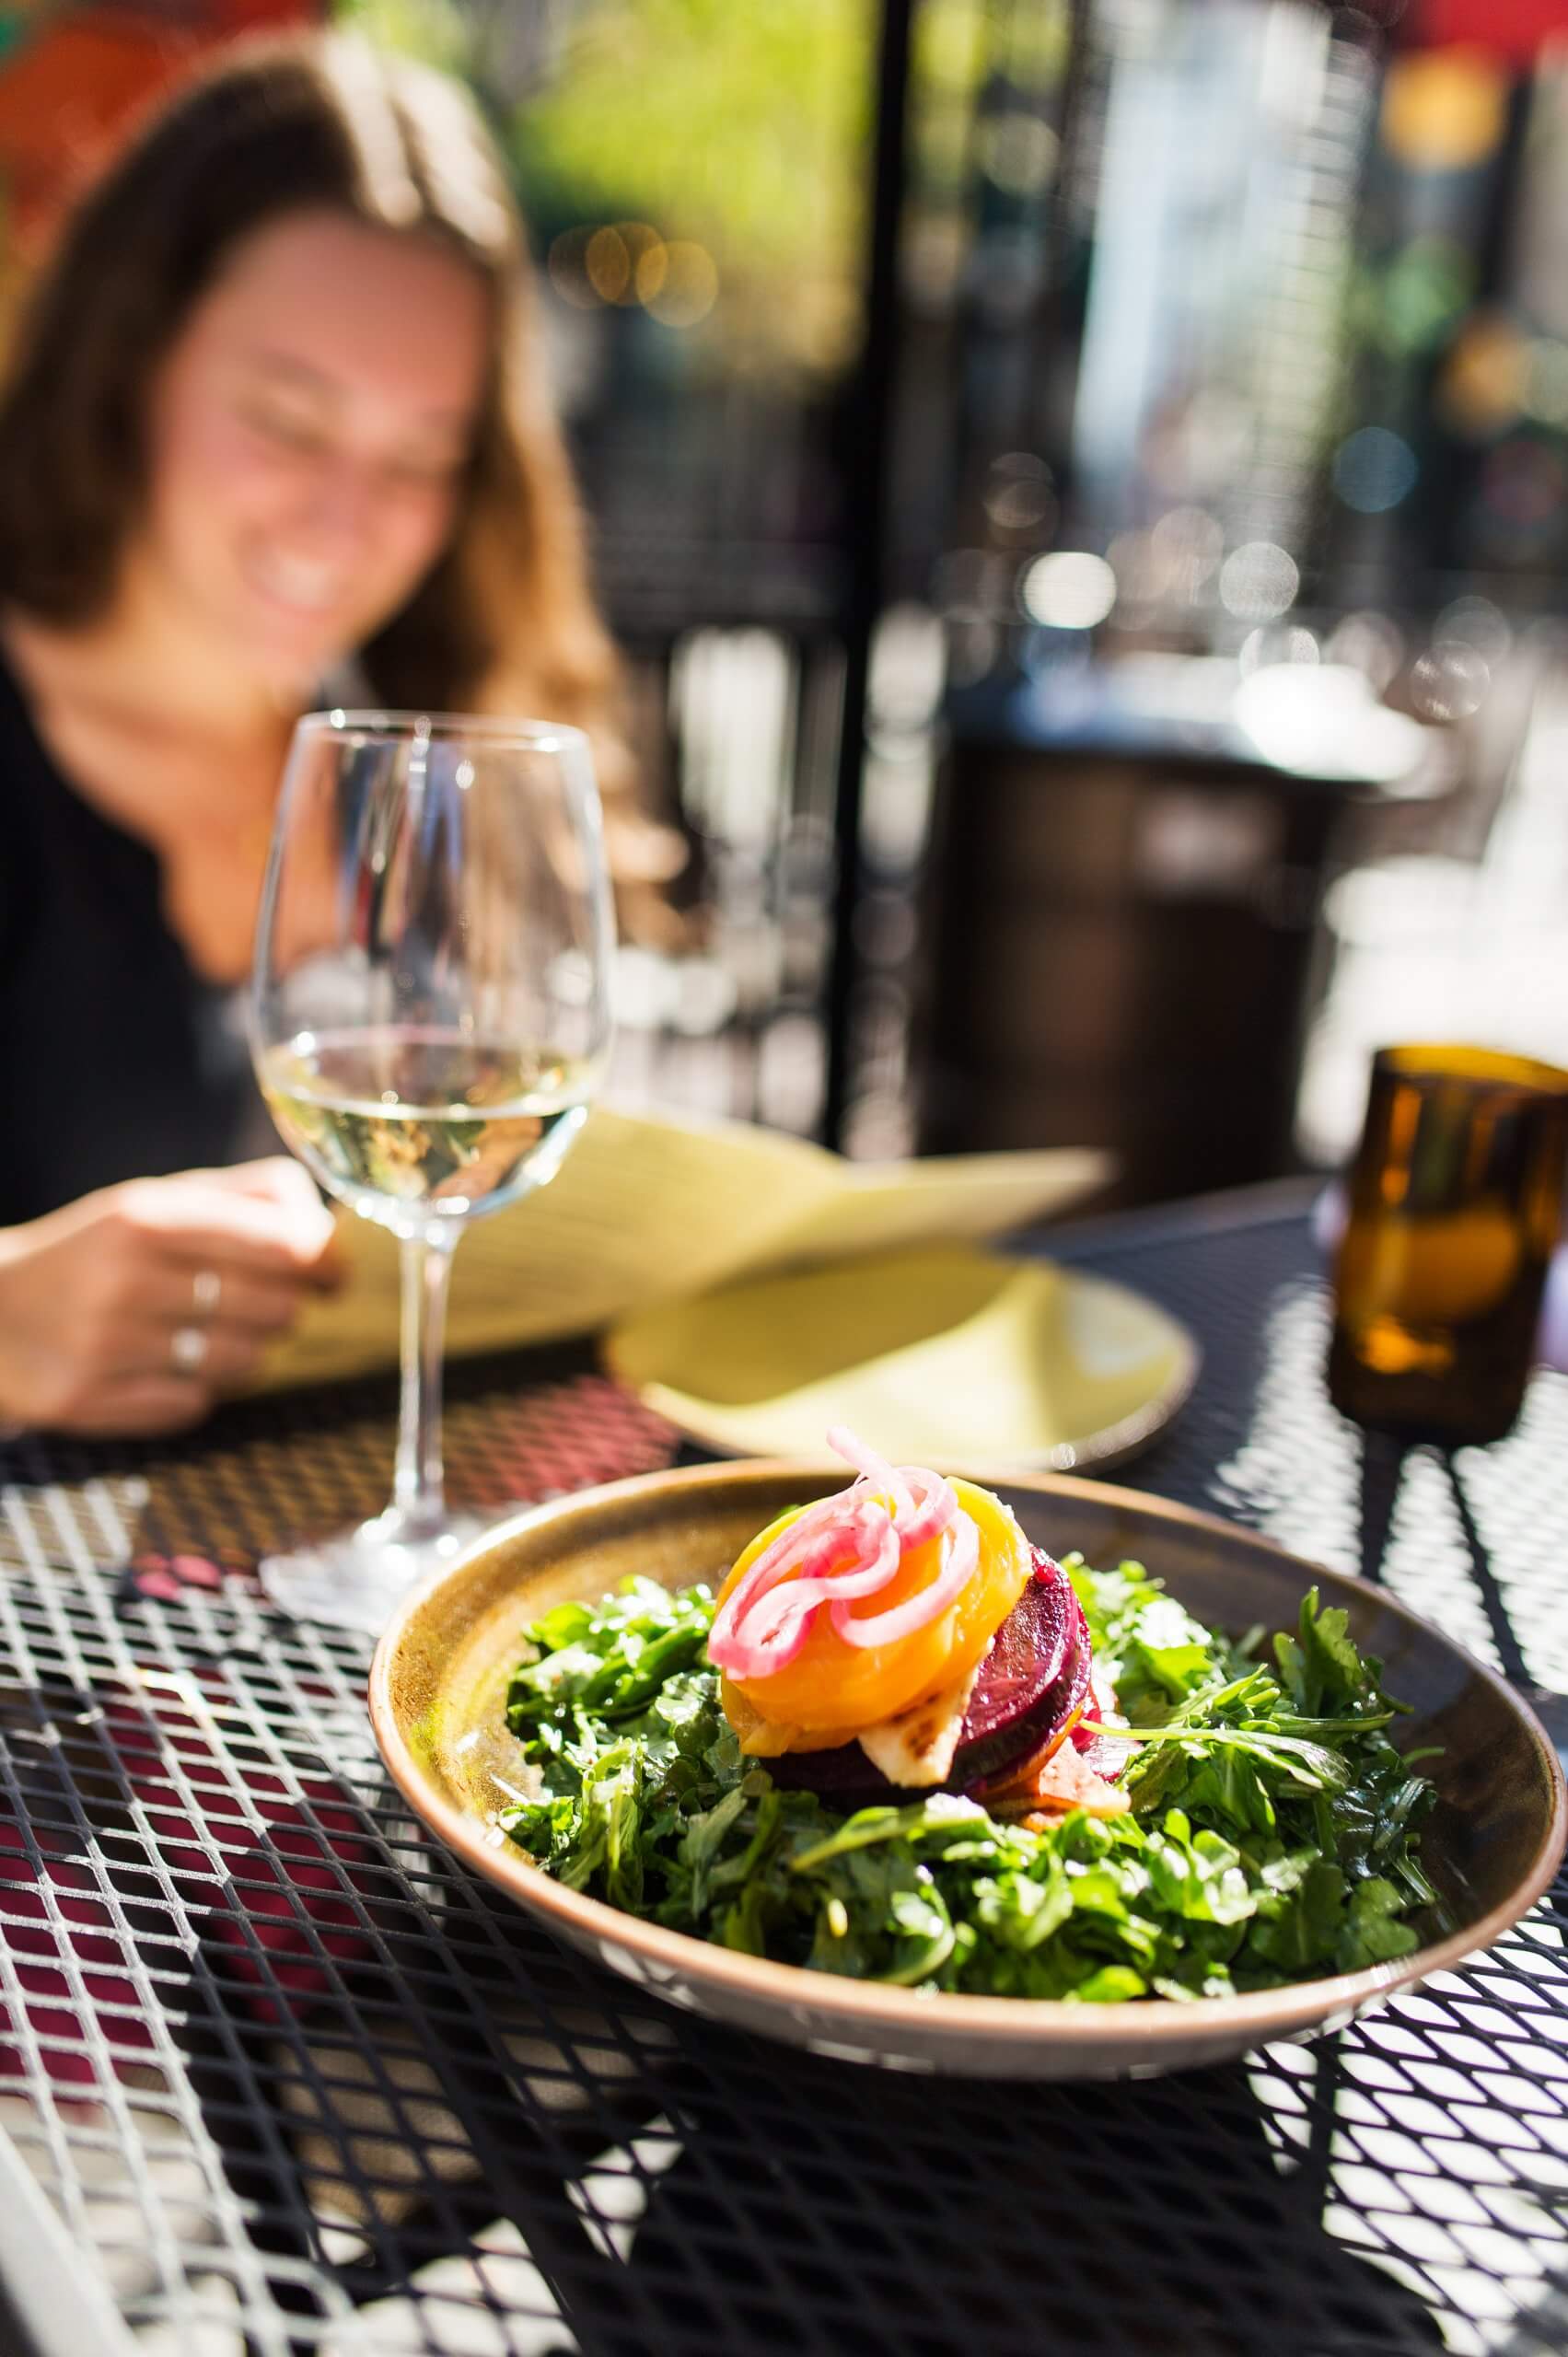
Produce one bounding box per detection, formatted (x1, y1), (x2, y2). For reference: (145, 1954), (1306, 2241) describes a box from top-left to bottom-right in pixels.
(136, 212), (491, 691)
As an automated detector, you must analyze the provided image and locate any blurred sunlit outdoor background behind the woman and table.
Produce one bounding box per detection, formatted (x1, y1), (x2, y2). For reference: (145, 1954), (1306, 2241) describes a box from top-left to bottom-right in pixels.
(0, 0), (1568, 1202)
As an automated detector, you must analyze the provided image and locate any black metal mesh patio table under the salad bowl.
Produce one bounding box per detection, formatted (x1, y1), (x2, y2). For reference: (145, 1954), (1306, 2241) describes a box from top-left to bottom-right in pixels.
(0, 1197), (1568, 2357)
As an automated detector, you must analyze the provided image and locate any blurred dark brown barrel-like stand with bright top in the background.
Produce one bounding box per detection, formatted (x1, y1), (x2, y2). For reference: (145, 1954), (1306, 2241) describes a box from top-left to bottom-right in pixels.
(920, 657), (1431, 1204)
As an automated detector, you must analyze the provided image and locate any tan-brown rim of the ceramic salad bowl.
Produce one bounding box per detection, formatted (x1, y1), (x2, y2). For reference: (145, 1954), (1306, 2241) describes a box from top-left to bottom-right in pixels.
(368, 1457), (1568, 2053)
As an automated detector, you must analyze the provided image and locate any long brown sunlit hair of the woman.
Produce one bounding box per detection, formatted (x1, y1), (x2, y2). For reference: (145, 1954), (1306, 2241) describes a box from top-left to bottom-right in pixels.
(0, 33), (625, 787)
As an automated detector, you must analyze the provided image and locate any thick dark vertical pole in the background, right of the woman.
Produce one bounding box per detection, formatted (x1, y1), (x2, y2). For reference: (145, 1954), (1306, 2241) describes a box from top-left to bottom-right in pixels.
(823, 0), (915, 1145)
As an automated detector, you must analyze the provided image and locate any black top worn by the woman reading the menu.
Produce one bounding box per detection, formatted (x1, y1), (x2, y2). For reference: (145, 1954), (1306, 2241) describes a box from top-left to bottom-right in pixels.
(0, 660), (278, 1228)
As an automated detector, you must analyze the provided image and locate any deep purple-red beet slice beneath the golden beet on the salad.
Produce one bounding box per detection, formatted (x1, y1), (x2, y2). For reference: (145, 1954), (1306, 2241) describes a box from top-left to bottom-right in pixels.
(764, 1549), (1089, 1808)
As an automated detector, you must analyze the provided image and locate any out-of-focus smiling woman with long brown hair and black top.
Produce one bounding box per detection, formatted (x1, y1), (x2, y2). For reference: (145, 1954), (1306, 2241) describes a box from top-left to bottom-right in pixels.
(0, 35), (655, 1433)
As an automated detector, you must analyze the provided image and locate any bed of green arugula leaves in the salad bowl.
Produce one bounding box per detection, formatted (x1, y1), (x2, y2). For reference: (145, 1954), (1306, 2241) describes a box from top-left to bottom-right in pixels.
(500, 1558), (1438, 2003)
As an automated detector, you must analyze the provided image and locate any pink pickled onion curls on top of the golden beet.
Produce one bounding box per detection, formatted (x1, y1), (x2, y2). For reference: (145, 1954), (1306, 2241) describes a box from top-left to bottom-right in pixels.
(707, 1423), (981, 1680)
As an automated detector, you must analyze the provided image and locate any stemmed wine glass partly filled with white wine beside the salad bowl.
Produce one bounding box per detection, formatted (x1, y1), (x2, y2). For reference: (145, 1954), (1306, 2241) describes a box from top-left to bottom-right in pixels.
(250, 712), (613, 1631)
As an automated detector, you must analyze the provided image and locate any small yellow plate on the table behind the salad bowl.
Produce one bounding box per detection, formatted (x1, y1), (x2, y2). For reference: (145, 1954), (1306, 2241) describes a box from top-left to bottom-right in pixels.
(604, 1245), (1198, 1473)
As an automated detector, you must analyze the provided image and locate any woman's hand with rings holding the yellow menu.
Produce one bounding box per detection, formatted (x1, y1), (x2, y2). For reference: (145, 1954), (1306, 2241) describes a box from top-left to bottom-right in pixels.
(0, 1155), (337, 1433)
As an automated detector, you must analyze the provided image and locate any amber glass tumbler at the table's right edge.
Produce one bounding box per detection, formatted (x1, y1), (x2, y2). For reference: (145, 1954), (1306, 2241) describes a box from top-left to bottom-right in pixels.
(1328, 1047), (1568, 1443)
